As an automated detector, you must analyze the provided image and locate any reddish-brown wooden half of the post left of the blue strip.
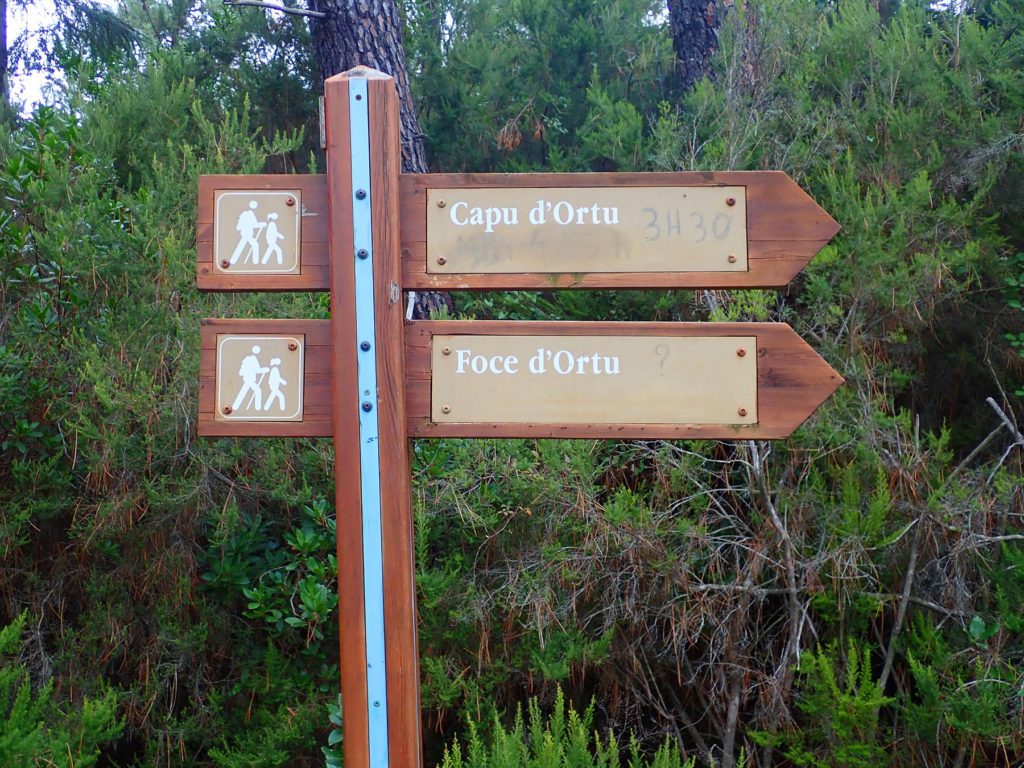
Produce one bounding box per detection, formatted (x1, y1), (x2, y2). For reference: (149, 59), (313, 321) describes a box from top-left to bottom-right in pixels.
(324, 76), (370, 768)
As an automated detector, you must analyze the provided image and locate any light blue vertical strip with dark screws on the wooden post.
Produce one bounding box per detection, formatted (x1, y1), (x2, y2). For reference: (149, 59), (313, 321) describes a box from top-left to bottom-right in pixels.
(348, 78), (388, 768)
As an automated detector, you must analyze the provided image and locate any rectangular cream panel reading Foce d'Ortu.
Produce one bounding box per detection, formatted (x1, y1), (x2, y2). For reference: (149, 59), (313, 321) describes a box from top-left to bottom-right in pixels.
(430, 336), (758, 424)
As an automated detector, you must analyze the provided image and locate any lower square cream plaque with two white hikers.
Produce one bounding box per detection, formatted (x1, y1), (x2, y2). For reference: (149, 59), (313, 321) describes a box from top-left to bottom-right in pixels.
(216, 334), (305, 421)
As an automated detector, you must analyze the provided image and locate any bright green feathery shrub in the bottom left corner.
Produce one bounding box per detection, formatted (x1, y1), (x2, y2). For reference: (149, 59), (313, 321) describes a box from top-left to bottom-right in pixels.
(0, 613), (124, 768)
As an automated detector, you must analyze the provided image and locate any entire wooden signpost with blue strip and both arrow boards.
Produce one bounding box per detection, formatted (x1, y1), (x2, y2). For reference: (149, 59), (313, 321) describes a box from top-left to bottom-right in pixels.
(197, 68), (843, 768)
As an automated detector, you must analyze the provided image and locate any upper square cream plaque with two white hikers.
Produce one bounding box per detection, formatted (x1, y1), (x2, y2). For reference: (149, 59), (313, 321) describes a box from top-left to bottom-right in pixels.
(213, 189), (302, 274)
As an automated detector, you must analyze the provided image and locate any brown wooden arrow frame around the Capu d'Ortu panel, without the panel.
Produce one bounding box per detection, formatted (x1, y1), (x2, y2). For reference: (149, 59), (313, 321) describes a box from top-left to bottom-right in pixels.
(399, 171), (840, 291)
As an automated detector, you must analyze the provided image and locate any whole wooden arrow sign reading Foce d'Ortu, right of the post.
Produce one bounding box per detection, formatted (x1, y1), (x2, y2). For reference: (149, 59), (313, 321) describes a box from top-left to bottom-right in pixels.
(406, 321), (843, 439)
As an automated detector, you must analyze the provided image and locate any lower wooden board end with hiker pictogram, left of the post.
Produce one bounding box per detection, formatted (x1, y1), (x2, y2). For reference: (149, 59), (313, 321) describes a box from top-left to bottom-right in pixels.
(199, 319), (333, 437)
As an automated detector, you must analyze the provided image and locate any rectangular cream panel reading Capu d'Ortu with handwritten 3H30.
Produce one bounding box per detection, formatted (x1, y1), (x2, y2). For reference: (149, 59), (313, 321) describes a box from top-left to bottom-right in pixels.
(427, 186), (748, 274)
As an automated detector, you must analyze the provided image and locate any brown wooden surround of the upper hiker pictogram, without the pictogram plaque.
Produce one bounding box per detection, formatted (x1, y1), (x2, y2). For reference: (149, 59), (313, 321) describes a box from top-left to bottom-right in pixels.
(196, 174), (329, 291)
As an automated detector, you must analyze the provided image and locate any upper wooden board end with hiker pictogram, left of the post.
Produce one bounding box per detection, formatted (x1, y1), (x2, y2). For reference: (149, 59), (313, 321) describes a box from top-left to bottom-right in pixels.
(196, 175), (330, 291)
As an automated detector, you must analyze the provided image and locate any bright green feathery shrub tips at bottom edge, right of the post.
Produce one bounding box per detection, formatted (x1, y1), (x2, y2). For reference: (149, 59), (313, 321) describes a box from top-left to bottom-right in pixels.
(440, 688), (694, 768)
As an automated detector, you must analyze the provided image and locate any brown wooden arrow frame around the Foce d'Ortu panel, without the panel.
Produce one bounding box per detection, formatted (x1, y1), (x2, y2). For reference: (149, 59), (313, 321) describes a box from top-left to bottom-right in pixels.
(406, 321), (844, 440)
